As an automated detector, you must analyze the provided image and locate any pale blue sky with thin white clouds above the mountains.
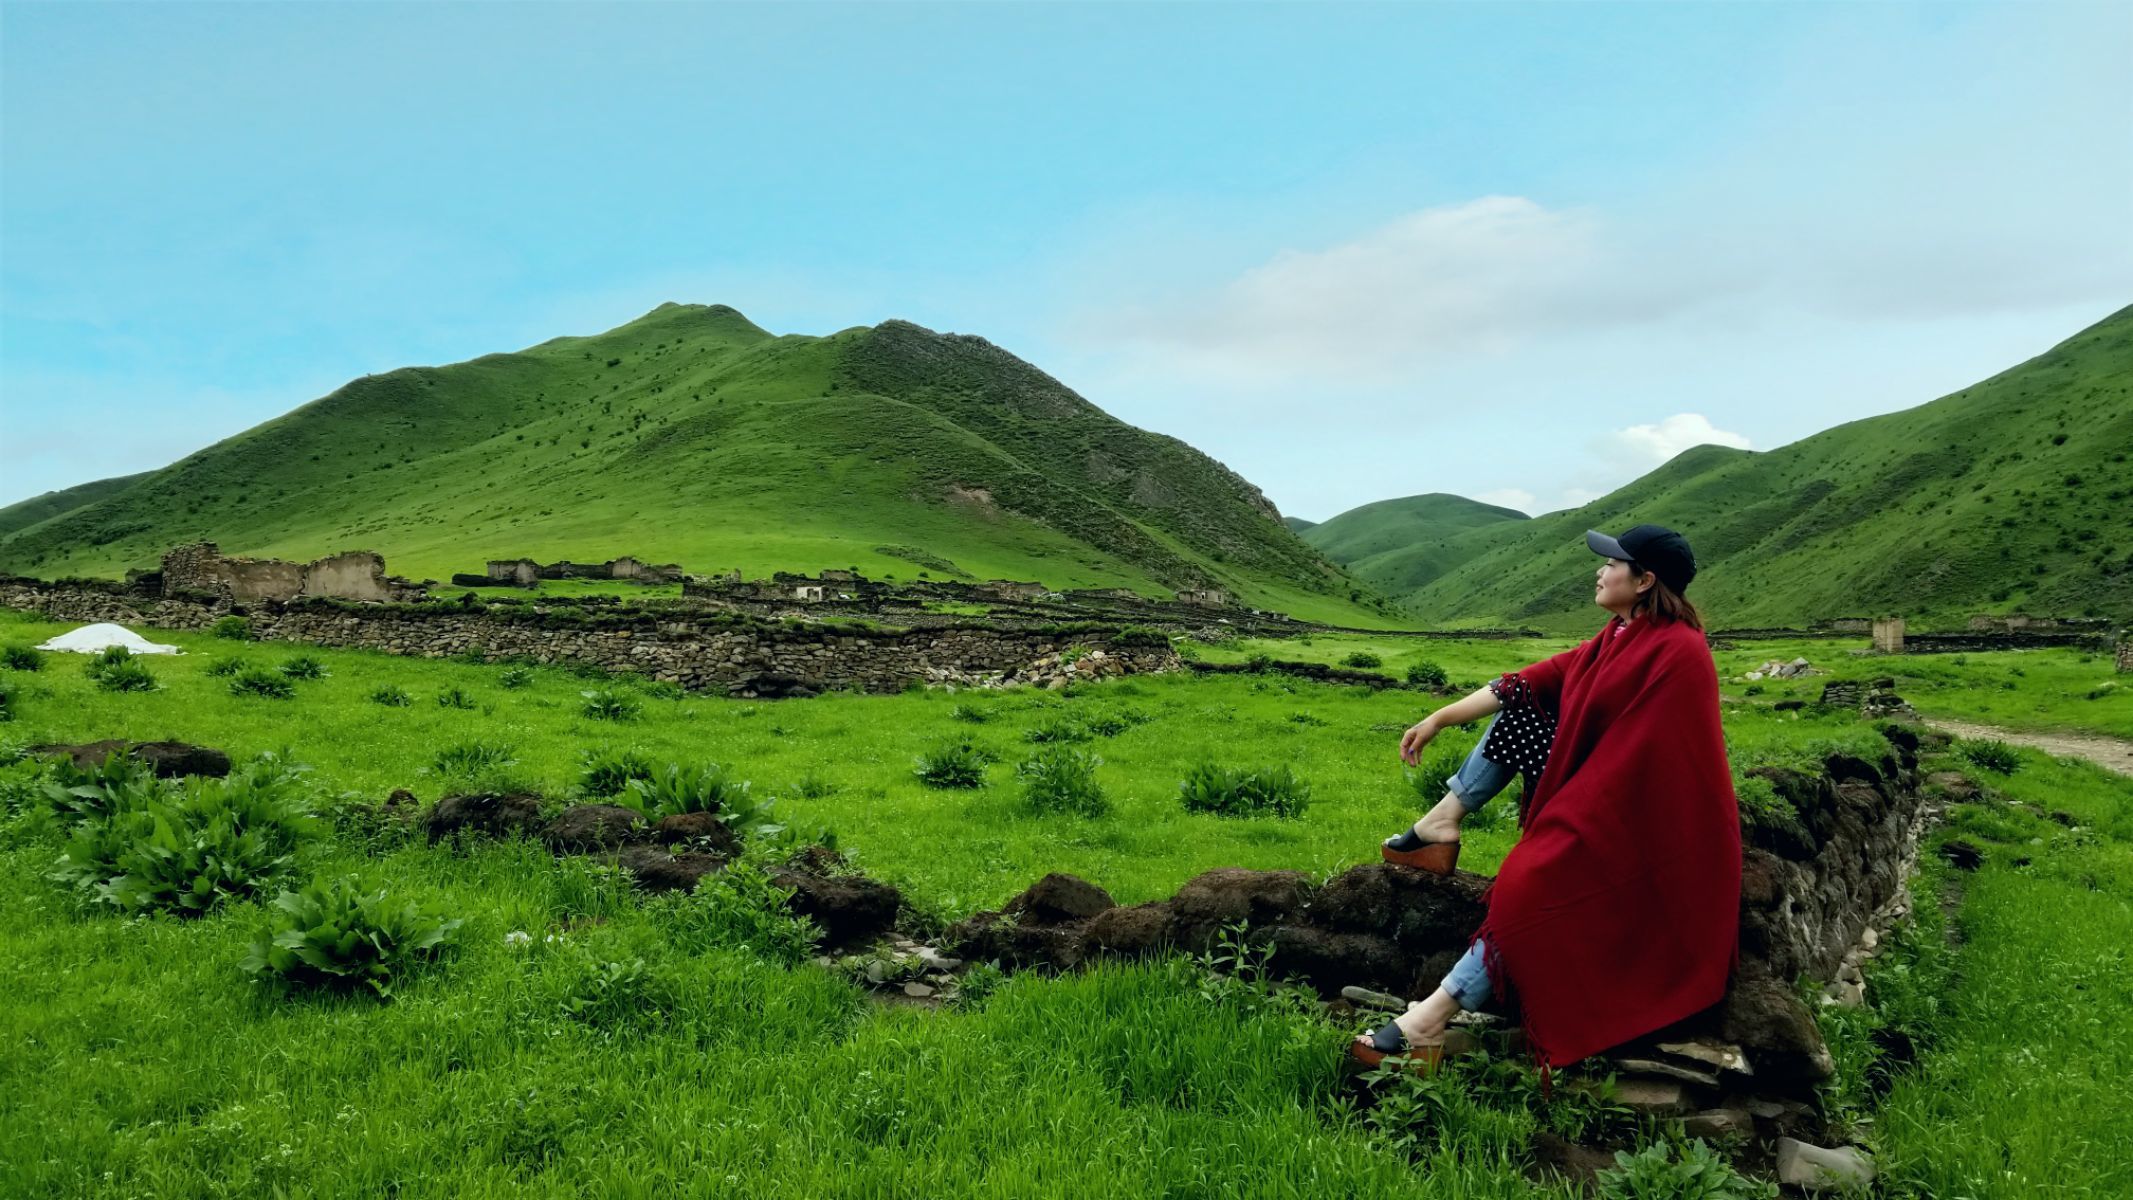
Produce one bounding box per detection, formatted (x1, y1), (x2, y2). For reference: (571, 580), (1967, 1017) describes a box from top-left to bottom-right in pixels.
(0, 0), (2133, 518)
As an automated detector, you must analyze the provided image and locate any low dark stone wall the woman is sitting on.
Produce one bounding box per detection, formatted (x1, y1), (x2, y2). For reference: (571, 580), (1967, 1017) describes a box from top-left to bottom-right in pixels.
(949, 725), (1926, 1091)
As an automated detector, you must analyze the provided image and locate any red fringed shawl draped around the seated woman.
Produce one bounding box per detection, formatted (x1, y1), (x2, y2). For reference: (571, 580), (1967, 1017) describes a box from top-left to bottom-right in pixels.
(1478, 618), (1741, 1066)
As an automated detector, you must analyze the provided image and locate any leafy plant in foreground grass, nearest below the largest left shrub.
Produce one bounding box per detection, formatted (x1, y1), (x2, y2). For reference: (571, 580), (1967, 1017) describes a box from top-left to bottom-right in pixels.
(243, 878), (461, 1000)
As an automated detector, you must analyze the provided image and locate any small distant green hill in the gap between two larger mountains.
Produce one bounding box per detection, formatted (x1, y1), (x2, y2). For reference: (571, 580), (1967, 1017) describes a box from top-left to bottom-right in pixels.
(1303, 492), (1529, 595)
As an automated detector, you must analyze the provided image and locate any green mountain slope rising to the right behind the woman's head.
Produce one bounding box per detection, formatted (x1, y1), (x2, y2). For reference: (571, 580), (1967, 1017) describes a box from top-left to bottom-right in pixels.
(1399, 307), (2133, 629)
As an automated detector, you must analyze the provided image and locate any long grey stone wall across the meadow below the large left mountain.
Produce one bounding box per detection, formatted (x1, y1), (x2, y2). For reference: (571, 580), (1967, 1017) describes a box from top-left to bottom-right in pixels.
(0, 580), (1180, 697)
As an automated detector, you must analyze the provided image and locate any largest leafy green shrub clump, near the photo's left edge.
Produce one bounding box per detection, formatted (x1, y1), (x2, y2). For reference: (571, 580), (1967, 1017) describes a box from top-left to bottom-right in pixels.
(53, 757), (318, 914)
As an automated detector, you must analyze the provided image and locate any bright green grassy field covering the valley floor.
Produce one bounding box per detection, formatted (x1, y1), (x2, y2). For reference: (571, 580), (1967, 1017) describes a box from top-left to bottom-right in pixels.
(0, 614), (2133, 1198)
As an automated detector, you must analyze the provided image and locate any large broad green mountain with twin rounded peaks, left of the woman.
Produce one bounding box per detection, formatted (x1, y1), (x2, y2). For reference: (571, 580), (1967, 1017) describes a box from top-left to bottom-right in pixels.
(0, 305), (1367, 622)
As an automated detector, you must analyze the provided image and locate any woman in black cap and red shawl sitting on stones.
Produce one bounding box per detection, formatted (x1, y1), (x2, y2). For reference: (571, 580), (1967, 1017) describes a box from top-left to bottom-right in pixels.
(1352, 524), (1741, 1068)
